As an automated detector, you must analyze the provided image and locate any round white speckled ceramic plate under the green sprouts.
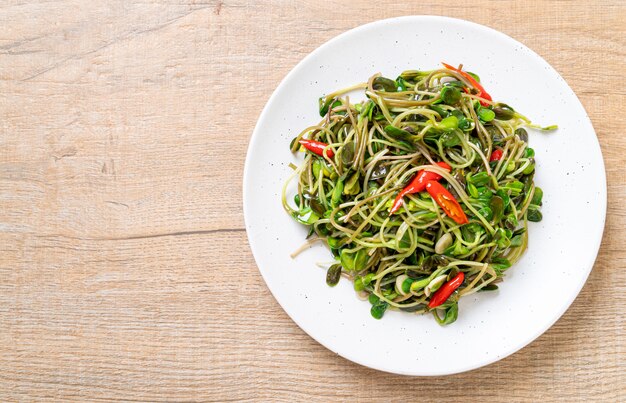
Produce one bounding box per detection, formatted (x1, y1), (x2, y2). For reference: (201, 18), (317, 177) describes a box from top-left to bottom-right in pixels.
(243, 16), (606, 375)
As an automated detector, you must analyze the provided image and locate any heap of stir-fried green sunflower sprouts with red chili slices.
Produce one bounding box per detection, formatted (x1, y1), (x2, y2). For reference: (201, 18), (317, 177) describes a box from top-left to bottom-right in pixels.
(282, 66), (556, 324)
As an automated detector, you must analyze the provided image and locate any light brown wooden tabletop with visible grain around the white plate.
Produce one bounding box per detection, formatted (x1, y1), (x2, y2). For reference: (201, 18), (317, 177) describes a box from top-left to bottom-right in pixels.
(0, 0), (626, 402)
